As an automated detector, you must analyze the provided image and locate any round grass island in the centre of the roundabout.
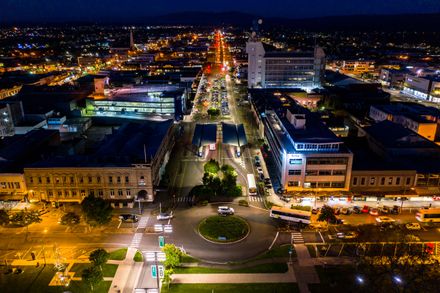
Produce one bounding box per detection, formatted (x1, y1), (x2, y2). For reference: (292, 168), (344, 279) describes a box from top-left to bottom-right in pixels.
(199, 216), (249, 242)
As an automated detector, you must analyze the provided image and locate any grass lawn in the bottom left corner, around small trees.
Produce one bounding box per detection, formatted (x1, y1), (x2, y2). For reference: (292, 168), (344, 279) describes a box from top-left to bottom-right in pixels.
(0, 265), (111, 293)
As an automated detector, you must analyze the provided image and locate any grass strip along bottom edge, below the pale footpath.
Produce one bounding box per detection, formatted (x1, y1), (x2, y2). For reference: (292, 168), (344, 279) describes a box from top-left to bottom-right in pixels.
(161, 283), (299, 293)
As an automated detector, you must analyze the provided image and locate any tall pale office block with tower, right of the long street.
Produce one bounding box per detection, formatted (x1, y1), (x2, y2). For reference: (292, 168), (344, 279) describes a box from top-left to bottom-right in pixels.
(246, 37), (325, 90)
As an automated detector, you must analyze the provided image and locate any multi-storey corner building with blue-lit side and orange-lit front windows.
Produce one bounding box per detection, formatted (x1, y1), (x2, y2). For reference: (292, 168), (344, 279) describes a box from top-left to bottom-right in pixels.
(251, 90), (353, 193)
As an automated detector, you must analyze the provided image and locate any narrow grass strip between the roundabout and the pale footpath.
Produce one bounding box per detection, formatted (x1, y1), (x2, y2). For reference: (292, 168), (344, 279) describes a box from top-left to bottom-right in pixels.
(174, 263), (288, 274)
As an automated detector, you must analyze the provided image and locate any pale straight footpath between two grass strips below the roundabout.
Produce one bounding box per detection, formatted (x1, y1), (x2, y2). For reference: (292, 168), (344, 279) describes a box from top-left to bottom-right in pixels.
(173, 265), (296, 284)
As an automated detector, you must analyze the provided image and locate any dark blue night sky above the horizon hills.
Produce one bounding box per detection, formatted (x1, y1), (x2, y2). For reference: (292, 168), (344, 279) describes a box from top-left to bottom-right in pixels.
(0, 0), (440, 22)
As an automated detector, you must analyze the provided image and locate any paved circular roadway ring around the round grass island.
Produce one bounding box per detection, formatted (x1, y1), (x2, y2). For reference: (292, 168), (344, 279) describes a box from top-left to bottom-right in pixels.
(170, 204), (277, 263)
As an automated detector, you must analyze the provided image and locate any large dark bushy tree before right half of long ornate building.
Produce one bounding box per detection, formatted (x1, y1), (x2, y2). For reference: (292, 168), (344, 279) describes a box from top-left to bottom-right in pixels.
(81, 195), (113, 224)
